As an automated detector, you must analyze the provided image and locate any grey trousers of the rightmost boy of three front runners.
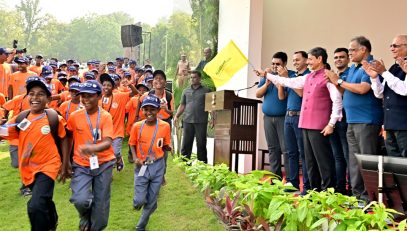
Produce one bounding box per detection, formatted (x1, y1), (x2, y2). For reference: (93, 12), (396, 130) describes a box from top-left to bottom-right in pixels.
(133, 158), (165, 231)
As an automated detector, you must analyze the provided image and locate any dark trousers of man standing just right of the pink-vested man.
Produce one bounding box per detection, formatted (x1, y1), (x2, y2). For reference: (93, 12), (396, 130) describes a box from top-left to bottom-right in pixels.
(329, 121), (349, 194)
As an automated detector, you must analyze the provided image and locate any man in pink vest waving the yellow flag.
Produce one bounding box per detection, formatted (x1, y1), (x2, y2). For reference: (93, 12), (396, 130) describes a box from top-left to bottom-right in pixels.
(257, 47), (342, 191)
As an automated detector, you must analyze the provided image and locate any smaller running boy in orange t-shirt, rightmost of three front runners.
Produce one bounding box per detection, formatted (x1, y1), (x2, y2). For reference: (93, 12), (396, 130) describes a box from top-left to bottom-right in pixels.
(129, 95), (172, 230)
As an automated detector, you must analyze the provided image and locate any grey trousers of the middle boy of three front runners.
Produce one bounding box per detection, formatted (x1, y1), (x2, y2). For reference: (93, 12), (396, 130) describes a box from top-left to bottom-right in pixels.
(69, 160), (116, 231)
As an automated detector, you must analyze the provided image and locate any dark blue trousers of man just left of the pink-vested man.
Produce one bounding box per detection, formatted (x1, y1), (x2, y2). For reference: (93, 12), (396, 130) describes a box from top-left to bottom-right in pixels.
(284, 115), (311, 191)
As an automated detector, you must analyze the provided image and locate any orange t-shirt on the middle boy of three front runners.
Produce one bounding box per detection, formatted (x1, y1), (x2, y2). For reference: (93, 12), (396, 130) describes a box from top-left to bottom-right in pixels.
(66, 109), (115, 167)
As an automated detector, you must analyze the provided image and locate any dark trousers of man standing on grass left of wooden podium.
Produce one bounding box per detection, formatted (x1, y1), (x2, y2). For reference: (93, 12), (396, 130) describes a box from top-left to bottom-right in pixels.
(181, 122), (208, 163)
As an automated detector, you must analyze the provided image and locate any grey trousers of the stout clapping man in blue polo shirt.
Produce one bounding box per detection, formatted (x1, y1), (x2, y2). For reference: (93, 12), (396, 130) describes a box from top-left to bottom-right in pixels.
(346, 124), (381, 199)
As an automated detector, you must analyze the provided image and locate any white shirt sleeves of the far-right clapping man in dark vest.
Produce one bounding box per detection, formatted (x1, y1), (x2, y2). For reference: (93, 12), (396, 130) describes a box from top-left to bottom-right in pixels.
(370, 71), (407, 99)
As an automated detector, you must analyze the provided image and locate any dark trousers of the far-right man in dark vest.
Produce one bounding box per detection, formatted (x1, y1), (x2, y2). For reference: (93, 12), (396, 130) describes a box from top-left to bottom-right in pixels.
(386, 130), (407, 157)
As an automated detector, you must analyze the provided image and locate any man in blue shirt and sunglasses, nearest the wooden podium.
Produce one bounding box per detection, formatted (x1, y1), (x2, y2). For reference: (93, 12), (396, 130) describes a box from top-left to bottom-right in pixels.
(256, 52), (289, 181)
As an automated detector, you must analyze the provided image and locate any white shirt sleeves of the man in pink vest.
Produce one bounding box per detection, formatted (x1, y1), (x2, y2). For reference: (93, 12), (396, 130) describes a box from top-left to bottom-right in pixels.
(266, 73), (342, 124)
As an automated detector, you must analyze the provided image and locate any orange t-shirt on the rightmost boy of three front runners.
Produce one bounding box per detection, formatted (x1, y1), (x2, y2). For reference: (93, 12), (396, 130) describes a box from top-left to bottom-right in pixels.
(129, 119), (171, 161)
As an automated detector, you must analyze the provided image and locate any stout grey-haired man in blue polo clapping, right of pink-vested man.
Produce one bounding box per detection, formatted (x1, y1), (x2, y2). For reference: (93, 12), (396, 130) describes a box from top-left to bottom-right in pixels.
(327, 36), (383, 200)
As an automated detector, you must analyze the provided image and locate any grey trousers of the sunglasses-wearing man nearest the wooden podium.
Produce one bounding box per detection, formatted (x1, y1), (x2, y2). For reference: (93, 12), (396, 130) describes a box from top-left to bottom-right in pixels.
(264, 115), (290, 181)
